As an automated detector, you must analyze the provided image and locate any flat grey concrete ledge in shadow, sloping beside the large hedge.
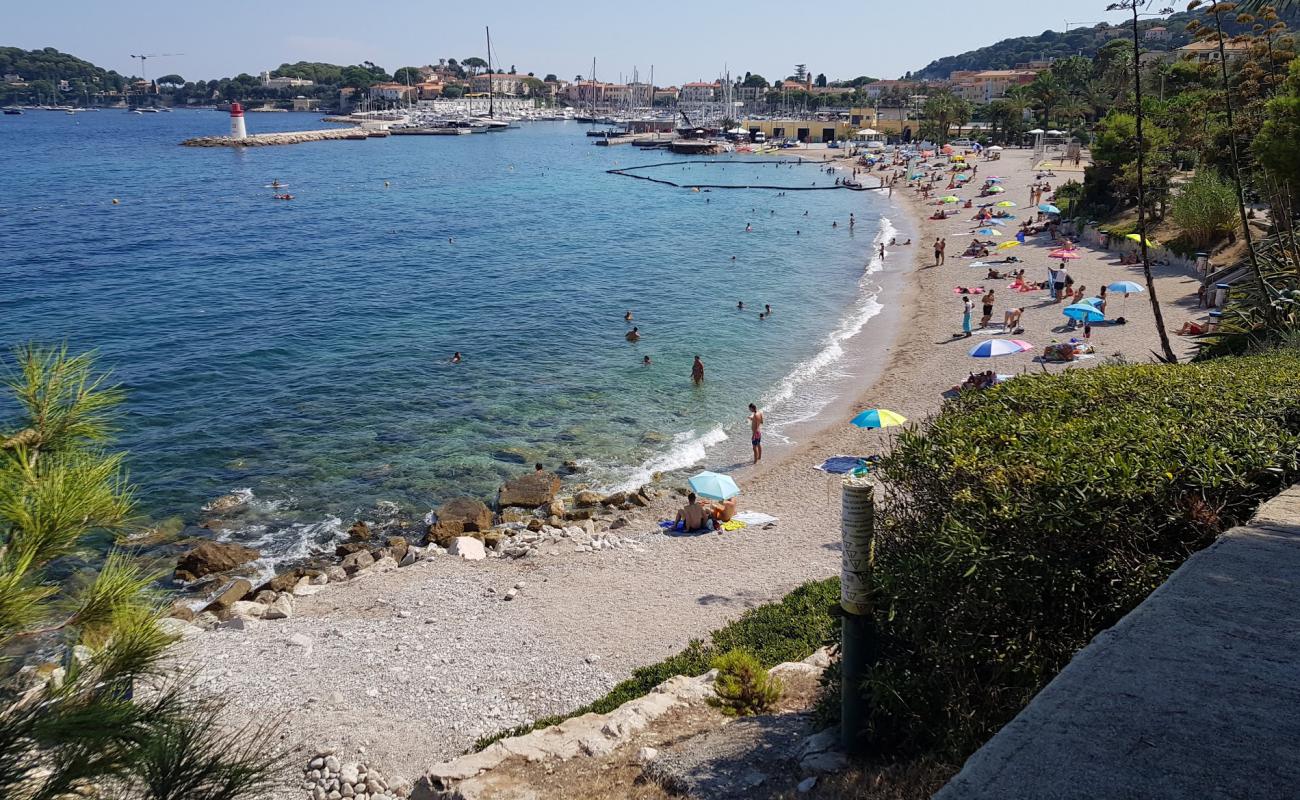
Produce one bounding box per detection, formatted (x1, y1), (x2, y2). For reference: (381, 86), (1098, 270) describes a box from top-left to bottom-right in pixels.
(935, 485), (1300, 800)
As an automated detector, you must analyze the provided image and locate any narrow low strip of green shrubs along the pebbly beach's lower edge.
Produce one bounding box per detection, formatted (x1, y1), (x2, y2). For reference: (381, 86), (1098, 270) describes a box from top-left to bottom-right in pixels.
(472, 578), (840, 751)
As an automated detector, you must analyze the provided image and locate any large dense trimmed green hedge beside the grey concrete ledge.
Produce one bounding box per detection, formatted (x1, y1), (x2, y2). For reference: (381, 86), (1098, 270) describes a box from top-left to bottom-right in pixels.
(865, 351), (1300, 758)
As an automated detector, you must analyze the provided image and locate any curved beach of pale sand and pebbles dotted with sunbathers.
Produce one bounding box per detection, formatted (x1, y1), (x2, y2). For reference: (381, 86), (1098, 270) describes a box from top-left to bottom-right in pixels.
(181, 150), (1197, 797)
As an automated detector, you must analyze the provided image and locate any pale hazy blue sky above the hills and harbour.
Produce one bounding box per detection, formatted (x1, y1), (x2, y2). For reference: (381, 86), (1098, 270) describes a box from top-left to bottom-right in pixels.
(0, 0), (1122, 85)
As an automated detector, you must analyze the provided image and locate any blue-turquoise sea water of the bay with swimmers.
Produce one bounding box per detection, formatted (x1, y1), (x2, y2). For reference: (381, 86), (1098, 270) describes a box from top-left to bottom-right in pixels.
(0, 111), (888, 564)
